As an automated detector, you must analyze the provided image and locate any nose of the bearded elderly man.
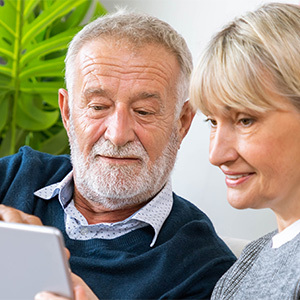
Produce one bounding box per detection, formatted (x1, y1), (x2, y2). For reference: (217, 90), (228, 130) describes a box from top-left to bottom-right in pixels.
(104, 106), (135, 146)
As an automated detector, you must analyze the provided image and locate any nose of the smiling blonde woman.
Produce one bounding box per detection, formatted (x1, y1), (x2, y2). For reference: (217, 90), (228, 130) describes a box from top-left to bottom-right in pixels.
(209, 126), (239, 166)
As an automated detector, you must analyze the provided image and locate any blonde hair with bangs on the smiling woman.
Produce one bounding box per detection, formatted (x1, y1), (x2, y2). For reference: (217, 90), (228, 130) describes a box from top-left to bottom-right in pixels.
(190, 3), (300, 115)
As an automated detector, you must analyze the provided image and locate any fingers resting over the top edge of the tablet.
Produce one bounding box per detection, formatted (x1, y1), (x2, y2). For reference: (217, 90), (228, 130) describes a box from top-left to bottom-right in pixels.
(0, 204), (43, 225)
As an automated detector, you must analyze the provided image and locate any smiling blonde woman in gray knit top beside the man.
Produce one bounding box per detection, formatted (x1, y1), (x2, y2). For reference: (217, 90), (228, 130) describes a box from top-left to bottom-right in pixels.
(191, 3), (300, 300)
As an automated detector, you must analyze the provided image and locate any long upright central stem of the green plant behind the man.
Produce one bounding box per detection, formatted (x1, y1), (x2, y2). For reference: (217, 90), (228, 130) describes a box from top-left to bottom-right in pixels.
(9, 0), (24, 154)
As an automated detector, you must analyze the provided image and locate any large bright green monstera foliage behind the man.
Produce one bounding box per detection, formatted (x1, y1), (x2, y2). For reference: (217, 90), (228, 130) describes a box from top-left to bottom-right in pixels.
(0, 0), (106, 156)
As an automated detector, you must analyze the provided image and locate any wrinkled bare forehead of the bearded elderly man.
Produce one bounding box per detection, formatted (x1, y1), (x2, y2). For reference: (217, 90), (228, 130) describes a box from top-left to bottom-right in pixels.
(75, 40), (180, 86)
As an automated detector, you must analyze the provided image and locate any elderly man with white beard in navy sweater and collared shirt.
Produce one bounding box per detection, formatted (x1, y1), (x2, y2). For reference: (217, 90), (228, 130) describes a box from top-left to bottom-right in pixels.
(0, 12), (235, 299)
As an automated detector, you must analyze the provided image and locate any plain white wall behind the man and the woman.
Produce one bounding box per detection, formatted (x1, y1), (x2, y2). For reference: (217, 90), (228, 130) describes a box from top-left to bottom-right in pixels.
(100, 0), (299, 239)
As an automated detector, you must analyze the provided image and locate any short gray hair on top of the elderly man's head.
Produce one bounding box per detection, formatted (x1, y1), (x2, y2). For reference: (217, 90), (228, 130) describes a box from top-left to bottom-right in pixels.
(65, 9), (193, 114)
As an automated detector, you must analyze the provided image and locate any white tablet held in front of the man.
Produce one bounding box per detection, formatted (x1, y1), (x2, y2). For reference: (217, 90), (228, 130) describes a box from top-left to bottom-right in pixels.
(0, 221), (73, 300)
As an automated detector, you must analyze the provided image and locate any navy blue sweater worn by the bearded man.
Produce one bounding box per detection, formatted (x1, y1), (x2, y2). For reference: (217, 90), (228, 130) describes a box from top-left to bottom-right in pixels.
(0, 147), (235, 300)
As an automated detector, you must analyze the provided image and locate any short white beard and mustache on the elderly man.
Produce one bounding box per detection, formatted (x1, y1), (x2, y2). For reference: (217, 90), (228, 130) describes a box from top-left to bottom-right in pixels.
(70, 121), (179, 210)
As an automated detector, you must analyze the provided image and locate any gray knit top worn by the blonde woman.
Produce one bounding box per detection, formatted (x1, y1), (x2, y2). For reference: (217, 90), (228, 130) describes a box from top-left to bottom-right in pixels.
(211, 231), (300, 300)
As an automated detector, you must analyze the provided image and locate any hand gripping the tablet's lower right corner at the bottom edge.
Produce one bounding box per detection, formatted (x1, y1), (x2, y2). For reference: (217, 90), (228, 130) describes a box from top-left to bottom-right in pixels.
(34, 273), (99, 300)
